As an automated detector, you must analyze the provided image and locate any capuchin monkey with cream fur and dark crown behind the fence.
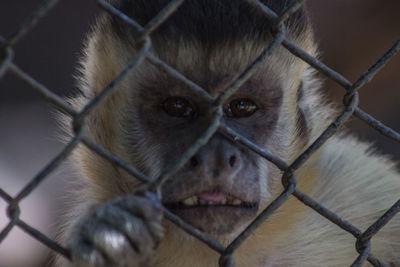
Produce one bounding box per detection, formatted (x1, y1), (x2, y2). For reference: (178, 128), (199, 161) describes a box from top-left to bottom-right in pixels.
(57, 0), (400, 267)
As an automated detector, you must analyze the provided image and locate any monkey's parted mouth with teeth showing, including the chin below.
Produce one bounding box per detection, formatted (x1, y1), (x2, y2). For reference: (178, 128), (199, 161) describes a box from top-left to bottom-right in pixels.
(164, 192), (259, 236)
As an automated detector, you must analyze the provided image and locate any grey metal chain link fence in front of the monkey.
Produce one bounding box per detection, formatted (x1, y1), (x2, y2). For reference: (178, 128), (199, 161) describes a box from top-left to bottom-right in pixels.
(0, 0), (400, 266)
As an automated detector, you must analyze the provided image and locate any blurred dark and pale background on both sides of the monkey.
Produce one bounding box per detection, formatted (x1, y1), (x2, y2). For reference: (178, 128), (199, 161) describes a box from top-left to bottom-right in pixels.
(0, 0), (400, 267)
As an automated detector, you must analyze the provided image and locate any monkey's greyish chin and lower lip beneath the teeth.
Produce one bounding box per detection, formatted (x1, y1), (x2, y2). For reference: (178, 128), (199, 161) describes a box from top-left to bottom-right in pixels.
(166, 203), (259, 237)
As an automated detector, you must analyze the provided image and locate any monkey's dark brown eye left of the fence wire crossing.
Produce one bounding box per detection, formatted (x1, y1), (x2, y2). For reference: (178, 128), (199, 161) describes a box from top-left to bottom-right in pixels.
(161, 97), (195, 118)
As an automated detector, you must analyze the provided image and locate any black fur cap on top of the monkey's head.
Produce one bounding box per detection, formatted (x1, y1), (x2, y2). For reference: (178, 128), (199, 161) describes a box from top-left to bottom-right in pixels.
(110, 0), (308, 45)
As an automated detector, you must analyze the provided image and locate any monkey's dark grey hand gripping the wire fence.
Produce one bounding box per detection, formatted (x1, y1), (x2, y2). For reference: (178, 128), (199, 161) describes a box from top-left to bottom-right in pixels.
(69, 193), (162, 267)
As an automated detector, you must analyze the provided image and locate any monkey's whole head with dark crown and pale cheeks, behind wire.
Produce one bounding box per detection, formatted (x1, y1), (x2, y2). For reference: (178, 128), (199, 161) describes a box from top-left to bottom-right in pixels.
(73, 0), (326, 242)
